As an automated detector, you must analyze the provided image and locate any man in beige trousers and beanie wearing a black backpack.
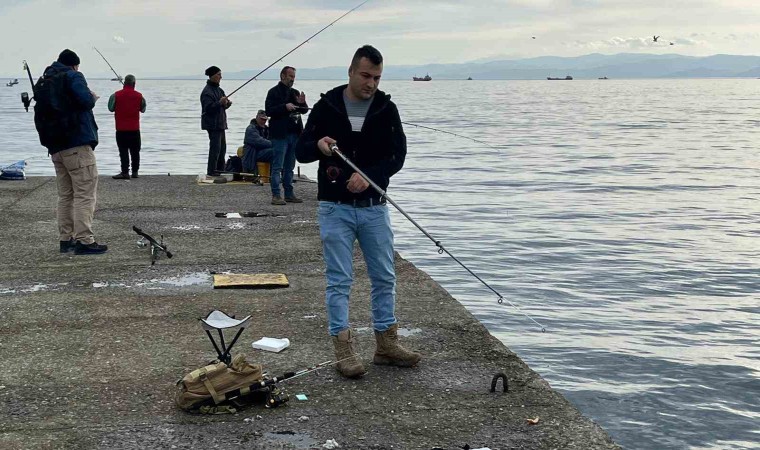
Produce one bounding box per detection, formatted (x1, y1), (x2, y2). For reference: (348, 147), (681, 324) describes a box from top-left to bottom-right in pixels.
(35, 49), (108, 255)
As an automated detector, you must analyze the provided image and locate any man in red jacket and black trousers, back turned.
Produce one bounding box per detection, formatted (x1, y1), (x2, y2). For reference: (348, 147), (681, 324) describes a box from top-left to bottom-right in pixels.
(108, 75), (146, 180)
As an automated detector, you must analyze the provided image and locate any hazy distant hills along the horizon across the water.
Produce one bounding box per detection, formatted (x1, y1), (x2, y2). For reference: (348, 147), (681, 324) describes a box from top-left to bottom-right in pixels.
(153, 53), (760, 80)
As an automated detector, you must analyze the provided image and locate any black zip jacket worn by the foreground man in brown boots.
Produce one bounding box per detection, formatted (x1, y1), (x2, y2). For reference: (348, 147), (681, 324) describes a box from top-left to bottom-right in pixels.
(296, 85), (406, 202)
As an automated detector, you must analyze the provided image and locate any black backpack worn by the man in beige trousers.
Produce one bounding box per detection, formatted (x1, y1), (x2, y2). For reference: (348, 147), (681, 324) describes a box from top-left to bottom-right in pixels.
(34, 68), (79, 151)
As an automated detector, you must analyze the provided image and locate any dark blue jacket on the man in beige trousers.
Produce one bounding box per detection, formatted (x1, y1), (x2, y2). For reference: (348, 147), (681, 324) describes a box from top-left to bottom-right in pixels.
(45, 61), (98, 154)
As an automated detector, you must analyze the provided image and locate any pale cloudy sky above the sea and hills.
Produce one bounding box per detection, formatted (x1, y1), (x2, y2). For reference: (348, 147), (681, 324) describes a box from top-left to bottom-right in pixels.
(0, 0), (760, 77)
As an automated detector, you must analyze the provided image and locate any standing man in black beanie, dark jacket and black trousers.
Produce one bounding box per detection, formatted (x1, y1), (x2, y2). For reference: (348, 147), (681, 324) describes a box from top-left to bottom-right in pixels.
(201, 66), (232, 176)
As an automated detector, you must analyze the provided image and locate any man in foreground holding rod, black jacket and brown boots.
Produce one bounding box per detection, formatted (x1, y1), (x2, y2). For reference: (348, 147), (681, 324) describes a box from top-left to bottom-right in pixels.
(296, 45), (422, 378)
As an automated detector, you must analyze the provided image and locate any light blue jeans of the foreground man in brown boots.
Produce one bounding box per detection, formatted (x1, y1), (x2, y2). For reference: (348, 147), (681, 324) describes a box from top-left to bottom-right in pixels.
(318, 202), (396, 336)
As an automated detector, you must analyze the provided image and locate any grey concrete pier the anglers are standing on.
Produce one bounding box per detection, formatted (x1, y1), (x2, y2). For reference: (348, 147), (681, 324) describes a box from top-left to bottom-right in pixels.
(0, 176), (619, 450)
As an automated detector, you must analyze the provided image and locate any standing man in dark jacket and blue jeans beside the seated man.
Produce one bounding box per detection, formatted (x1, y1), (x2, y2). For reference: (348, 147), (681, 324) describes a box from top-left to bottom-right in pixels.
(265, 66), (309, 205)
